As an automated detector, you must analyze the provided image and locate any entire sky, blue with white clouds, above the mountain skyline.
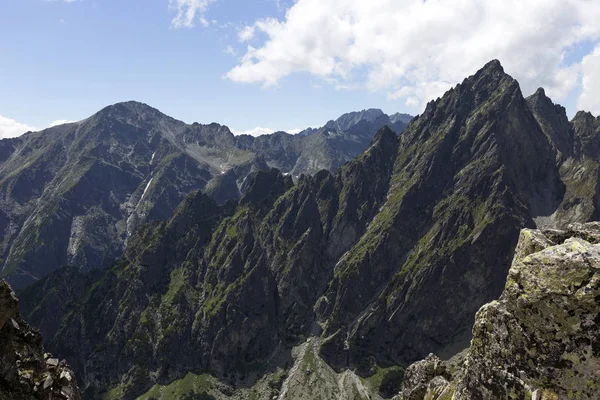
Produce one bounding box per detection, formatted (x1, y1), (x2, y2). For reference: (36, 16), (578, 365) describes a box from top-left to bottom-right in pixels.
(0, 0), (600, 137)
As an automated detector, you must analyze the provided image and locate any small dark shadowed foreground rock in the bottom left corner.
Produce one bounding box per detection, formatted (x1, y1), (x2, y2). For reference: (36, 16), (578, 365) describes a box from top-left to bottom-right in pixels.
(0, 281), (81, 400)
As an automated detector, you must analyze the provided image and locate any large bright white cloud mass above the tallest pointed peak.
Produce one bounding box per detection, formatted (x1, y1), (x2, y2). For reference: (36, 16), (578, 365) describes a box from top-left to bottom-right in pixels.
(226, 0), (600, 107)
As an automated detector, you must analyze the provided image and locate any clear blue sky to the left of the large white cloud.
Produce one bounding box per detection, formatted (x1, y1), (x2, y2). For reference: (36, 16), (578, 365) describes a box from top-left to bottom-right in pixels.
(0, 0), (398, 134)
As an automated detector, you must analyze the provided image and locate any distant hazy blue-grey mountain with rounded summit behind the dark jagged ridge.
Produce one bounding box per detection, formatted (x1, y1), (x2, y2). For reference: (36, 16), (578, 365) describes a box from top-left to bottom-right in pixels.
(0, 102), (406, 288)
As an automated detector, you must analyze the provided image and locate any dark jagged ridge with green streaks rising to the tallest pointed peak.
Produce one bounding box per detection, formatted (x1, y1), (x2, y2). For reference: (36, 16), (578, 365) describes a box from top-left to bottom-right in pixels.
(15, 61), (597, 399)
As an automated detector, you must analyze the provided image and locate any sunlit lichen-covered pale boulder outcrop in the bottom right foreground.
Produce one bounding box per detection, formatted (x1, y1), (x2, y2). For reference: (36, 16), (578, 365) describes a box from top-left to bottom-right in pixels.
(398, 222), (600, 400)
